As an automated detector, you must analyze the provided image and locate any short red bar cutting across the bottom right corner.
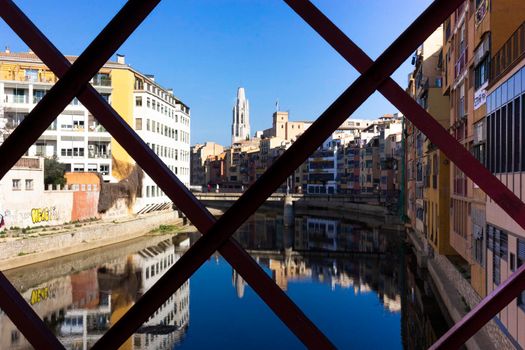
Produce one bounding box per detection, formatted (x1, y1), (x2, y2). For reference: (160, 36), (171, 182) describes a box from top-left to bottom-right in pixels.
(430, 265), (525, 350)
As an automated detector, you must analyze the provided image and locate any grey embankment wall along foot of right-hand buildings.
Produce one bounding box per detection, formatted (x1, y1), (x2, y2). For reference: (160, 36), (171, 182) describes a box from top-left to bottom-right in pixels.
(407, 229), (515, 350)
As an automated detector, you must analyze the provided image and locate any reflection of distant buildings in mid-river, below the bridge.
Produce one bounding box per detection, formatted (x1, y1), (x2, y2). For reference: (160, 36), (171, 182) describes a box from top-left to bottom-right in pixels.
(232, 213), (401, 312)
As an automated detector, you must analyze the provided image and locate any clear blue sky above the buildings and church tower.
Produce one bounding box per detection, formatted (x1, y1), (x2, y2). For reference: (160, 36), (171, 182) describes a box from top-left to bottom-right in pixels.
(0, 0), (431, 144)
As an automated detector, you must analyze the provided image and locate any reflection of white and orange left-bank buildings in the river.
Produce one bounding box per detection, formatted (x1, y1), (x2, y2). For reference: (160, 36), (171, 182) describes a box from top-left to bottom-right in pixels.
(0, 239), (189, 349)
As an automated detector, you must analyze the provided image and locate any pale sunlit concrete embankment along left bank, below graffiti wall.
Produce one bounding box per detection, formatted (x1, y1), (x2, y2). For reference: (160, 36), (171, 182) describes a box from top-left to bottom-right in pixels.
(0, 210), (183, 271)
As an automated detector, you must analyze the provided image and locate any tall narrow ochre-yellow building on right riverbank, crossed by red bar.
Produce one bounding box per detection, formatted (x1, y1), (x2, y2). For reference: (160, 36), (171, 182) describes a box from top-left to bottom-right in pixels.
(409, 26), (455, 255)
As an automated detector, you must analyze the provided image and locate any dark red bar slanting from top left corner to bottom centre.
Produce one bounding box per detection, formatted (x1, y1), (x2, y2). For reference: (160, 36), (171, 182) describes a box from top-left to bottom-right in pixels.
(2, 0), (332, 348)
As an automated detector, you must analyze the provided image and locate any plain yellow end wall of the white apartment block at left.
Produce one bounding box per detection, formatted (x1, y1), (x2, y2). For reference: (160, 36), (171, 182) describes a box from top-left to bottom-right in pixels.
(111, 69), (135, 180)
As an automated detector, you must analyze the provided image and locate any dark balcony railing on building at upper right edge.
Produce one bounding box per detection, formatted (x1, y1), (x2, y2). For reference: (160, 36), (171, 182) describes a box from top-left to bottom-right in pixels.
(490, 22), (525, 82)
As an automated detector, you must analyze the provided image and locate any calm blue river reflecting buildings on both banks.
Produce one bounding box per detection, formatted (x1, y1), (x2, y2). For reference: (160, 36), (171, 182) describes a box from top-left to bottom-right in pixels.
(0, 211), (448, 349)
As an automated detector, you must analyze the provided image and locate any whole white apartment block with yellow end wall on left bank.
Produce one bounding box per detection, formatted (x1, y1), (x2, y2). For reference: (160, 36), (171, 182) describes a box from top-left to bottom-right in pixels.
(0, 50), (190, 212)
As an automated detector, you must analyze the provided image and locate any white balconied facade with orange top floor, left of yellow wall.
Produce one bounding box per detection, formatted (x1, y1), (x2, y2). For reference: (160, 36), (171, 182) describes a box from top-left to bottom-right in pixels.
(0, 51), (112, 181)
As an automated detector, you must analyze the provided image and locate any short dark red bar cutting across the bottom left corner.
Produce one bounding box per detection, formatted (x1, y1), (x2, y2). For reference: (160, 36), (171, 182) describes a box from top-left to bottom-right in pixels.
(0, 272), (64, 349)
